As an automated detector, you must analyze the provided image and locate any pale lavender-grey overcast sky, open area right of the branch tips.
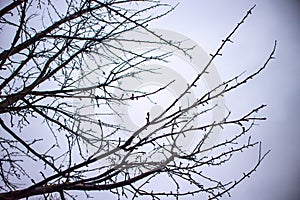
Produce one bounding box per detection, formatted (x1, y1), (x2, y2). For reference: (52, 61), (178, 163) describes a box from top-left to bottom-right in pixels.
(149, 0), (300, 200)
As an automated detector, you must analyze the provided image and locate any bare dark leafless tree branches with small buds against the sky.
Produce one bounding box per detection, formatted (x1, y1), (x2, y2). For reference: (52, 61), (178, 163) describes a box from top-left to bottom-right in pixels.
(0, 0), (276, 199)
